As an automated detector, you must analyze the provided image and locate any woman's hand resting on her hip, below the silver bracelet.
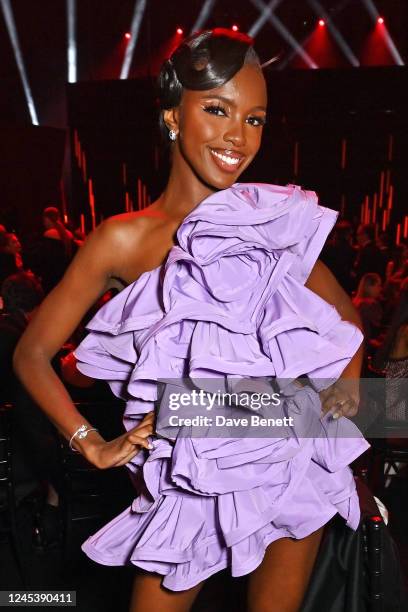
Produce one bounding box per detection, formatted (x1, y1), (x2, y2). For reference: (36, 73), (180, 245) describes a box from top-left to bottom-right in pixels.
(81, 411), (154, 470)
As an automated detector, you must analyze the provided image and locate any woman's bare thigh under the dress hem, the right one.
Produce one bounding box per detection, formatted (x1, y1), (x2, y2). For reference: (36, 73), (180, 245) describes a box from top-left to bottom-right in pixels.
(248, 527), (323, 612)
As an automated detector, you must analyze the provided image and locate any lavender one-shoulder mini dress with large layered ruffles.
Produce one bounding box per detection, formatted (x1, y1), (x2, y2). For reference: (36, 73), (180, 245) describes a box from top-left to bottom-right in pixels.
(75, 183), (369, 591)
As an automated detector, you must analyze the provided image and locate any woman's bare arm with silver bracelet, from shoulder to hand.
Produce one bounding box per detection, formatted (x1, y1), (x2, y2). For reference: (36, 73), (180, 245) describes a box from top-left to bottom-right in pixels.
(13, 220), (153, 467)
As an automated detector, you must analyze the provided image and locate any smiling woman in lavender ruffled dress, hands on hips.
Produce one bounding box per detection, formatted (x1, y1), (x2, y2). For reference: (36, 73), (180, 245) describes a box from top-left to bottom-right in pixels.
(15, 29), (368, 612)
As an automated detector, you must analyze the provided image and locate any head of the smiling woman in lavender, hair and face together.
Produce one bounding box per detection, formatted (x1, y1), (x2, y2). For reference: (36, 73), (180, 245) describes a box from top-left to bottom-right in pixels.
(159, 29), (267, 189)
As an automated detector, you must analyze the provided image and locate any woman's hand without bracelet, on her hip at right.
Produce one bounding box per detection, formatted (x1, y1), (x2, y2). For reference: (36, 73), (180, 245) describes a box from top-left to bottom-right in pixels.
(319, 378), (360, 419)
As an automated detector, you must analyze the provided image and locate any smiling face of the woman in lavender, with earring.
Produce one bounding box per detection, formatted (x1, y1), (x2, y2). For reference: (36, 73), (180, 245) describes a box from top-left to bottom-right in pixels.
(164, 64), (267, 190)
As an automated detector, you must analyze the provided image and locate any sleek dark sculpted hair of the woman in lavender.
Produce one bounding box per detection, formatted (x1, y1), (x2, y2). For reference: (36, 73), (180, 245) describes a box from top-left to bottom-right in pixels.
(158, 28), (260, 141)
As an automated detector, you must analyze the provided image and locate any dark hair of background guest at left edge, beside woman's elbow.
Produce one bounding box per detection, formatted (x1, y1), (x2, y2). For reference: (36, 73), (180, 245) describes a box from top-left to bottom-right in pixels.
(1, 272), (44, 313)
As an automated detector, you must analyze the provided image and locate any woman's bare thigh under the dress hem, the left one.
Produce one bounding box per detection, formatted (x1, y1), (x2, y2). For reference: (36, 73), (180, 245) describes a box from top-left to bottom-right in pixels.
(129, 572), (204, 612)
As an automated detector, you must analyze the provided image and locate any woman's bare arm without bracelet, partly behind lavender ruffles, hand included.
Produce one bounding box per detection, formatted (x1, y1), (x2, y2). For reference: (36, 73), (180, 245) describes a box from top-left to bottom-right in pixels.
(305, 259), (364, 416)
